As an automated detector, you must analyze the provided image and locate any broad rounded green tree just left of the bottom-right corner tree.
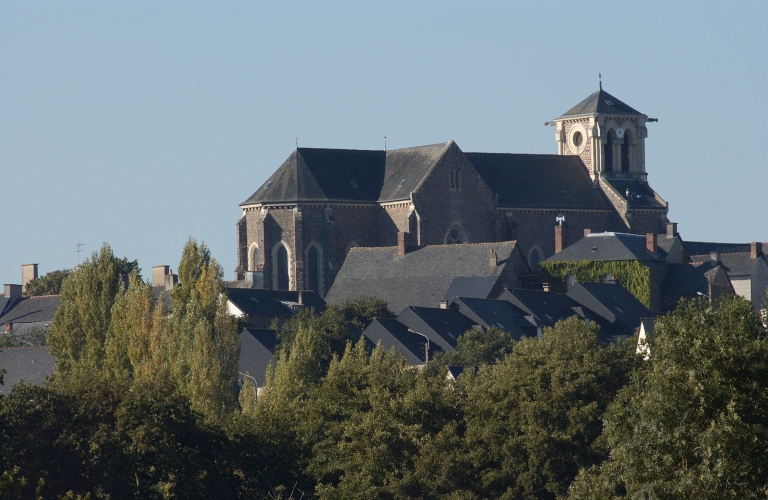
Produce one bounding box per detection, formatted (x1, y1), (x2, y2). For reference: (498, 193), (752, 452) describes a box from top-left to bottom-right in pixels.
(459, 317), (637, 498)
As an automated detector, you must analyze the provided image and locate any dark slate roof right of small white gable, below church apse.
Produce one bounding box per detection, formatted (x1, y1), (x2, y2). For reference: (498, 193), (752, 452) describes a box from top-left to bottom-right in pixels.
(227, 288), (325, 316)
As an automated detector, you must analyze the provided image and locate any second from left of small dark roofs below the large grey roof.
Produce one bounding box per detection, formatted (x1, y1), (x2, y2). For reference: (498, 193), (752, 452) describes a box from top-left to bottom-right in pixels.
(397, 306), (476, 351)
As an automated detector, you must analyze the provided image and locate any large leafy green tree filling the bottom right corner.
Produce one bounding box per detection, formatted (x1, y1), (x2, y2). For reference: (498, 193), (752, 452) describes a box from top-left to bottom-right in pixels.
(571, 296), (768, 499)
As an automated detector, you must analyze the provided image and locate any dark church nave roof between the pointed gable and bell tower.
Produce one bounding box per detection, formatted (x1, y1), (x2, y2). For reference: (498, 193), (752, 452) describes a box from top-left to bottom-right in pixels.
(464, 153), (613, 210)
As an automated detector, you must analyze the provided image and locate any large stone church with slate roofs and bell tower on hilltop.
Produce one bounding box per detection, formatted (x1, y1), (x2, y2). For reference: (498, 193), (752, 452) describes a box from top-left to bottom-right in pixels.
(235, 85), (668, 296)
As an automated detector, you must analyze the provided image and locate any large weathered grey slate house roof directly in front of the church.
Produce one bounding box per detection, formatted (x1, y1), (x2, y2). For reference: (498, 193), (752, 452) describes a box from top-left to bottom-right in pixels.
(326, 241), (516, 313)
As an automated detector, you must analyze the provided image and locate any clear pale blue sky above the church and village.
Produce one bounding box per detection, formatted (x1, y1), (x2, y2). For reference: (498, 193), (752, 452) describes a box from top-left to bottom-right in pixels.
(0, 0), (768, 283)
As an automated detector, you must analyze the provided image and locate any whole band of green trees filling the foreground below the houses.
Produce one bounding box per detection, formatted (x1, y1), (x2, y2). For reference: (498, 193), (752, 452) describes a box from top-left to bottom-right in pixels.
(0, 241), (768, 499)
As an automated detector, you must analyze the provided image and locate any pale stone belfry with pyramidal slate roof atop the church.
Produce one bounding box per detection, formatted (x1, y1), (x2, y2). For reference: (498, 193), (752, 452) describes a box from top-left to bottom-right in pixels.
(548, 82), (657, 184)
